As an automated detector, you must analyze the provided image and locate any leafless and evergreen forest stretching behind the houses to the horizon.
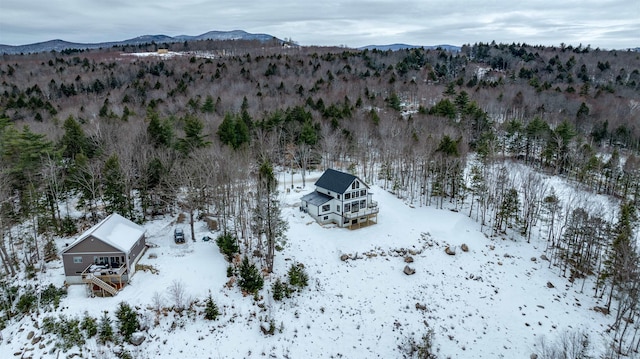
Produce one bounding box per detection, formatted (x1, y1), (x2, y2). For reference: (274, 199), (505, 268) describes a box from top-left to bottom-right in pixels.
(0, 41), (640, 357)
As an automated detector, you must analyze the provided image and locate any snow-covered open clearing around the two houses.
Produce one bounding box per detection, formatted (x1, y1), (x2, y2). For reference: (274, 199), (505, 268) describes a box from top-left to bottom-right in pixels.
(0, 171), (609, 358)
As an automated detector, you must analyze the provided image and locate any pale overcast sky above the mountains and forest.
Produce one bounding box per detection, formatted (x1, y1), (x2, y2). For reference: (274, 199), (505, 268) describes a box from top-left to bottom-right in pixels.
(0, 0), (640, 49)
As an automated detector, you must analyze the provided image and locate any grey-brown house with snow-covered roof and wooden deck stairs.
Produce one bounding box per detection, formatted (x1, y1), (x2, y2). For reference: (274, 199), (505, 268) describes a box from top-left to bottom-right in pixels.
(61, 213), (146, 295)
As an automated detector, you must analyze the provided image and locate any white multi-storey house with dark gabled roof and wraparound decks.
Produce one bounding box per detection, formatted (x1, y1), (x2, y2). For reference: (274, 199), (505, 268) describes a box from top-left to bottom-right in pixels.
(300, 169), (378, 228)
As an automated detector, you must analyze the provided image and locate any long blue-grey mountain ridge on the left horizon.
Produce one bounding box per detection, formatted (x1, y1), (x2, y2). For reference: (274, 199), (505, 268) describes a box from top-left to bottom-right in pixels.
(0, 30), (281, 54)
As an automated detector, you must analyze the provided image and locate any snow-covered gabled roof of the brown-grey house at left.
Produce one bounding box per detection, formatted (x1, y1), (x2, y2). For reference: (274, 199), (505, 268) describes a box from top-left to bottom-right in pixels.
(62, 213), (144, 254)
